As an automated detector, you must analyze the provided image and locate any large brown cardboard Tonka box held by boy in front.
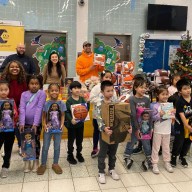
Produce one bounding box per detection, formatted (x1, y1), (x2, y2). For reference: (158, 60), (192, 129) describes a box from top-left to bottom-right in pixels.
(101, 103), (131, 144)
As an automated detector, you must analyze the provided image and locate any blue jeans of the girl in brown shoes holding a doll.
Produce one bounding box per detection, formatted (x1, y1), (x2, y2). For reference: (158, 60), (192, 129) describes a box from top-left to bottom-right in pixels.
(41, 132), (62, 165)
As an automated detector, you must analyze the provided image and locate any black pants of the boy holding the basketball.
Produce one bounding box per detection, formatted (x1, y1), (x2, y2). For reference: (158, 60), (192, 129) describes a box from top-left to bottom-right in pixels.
(67, 126), (84, 155)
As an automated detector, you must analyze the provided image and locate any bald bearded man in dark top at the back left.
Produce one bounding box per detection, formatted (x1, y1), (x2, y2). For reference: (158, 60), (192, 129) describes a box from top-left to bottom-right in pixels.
(0, 43), (36, 74)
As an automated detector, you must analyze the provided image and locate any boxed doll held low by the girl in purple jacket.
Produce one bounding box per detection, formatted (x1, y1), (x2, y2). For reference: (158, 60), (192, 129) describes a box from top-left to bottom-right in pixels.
(21, 127), (36, 161)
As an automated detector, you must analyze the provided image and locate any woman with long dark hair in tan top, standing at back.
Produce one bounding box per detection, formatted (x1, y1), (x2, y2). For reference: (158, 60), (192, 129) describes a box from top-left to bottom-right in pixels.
(43, 52), (66, 85)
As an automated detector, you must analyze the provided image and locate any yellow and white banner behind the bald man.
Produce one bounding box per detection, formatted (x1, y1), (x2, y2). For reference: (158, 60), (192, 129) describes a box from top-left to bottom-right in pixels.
(0, 25), (24, 66)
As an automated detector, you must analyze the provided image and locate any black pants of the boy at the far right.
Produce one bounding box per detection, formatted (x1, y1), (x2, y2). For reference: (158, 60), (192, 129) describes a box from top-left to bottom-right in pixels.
(172, 130), (191, 157)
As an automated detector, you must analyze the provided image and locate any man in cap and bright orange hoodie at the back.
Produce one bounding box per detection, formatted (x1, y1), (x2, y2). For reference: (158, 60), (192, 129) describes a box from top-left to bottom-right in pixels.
(76, 41), (104, 82)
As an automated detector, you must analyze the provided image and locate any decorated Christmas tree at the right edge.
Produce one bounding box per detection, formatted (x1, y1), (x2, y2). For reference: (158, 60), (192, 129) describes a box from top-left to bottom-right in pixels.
(170, 31), (192, 80)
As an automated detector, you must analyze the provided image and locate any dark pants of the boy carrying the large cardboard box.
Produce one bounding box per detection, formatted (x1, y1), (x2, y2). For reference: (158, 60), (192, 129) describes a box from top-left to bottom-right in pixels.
(98, 137), (118, 173)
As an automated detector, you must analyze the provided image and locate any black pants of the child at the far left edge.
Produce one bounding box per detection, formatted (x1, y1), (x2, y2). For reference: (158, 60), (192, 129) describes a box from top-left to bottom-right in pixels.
(0, 132), (15, 168)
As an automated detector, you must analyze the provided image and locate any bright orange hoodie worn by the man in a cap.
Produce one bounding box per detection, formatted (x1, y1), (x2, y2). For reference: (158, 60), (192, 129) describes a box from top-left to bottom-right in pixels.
(76, 50), (104, 82)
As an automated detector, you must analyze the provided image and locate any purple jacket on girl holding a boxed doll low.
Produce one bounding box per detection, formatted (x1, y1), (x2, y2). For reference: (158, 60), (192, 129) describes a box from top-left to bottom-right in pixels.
(19, 90), (46, 126)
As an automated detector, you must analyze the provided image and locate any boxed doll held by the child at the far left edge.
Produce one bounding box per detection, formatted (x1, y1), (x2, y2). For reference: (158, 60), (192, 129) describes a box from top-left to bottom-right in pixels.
(0, 99), (14, 132)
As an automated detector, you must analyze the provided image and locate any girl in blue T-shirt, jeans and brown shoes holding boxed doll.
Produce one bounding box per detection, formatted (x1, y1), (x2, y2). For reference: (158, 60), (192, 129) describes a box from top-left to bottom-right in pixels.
(37, 83), (66, 175)
